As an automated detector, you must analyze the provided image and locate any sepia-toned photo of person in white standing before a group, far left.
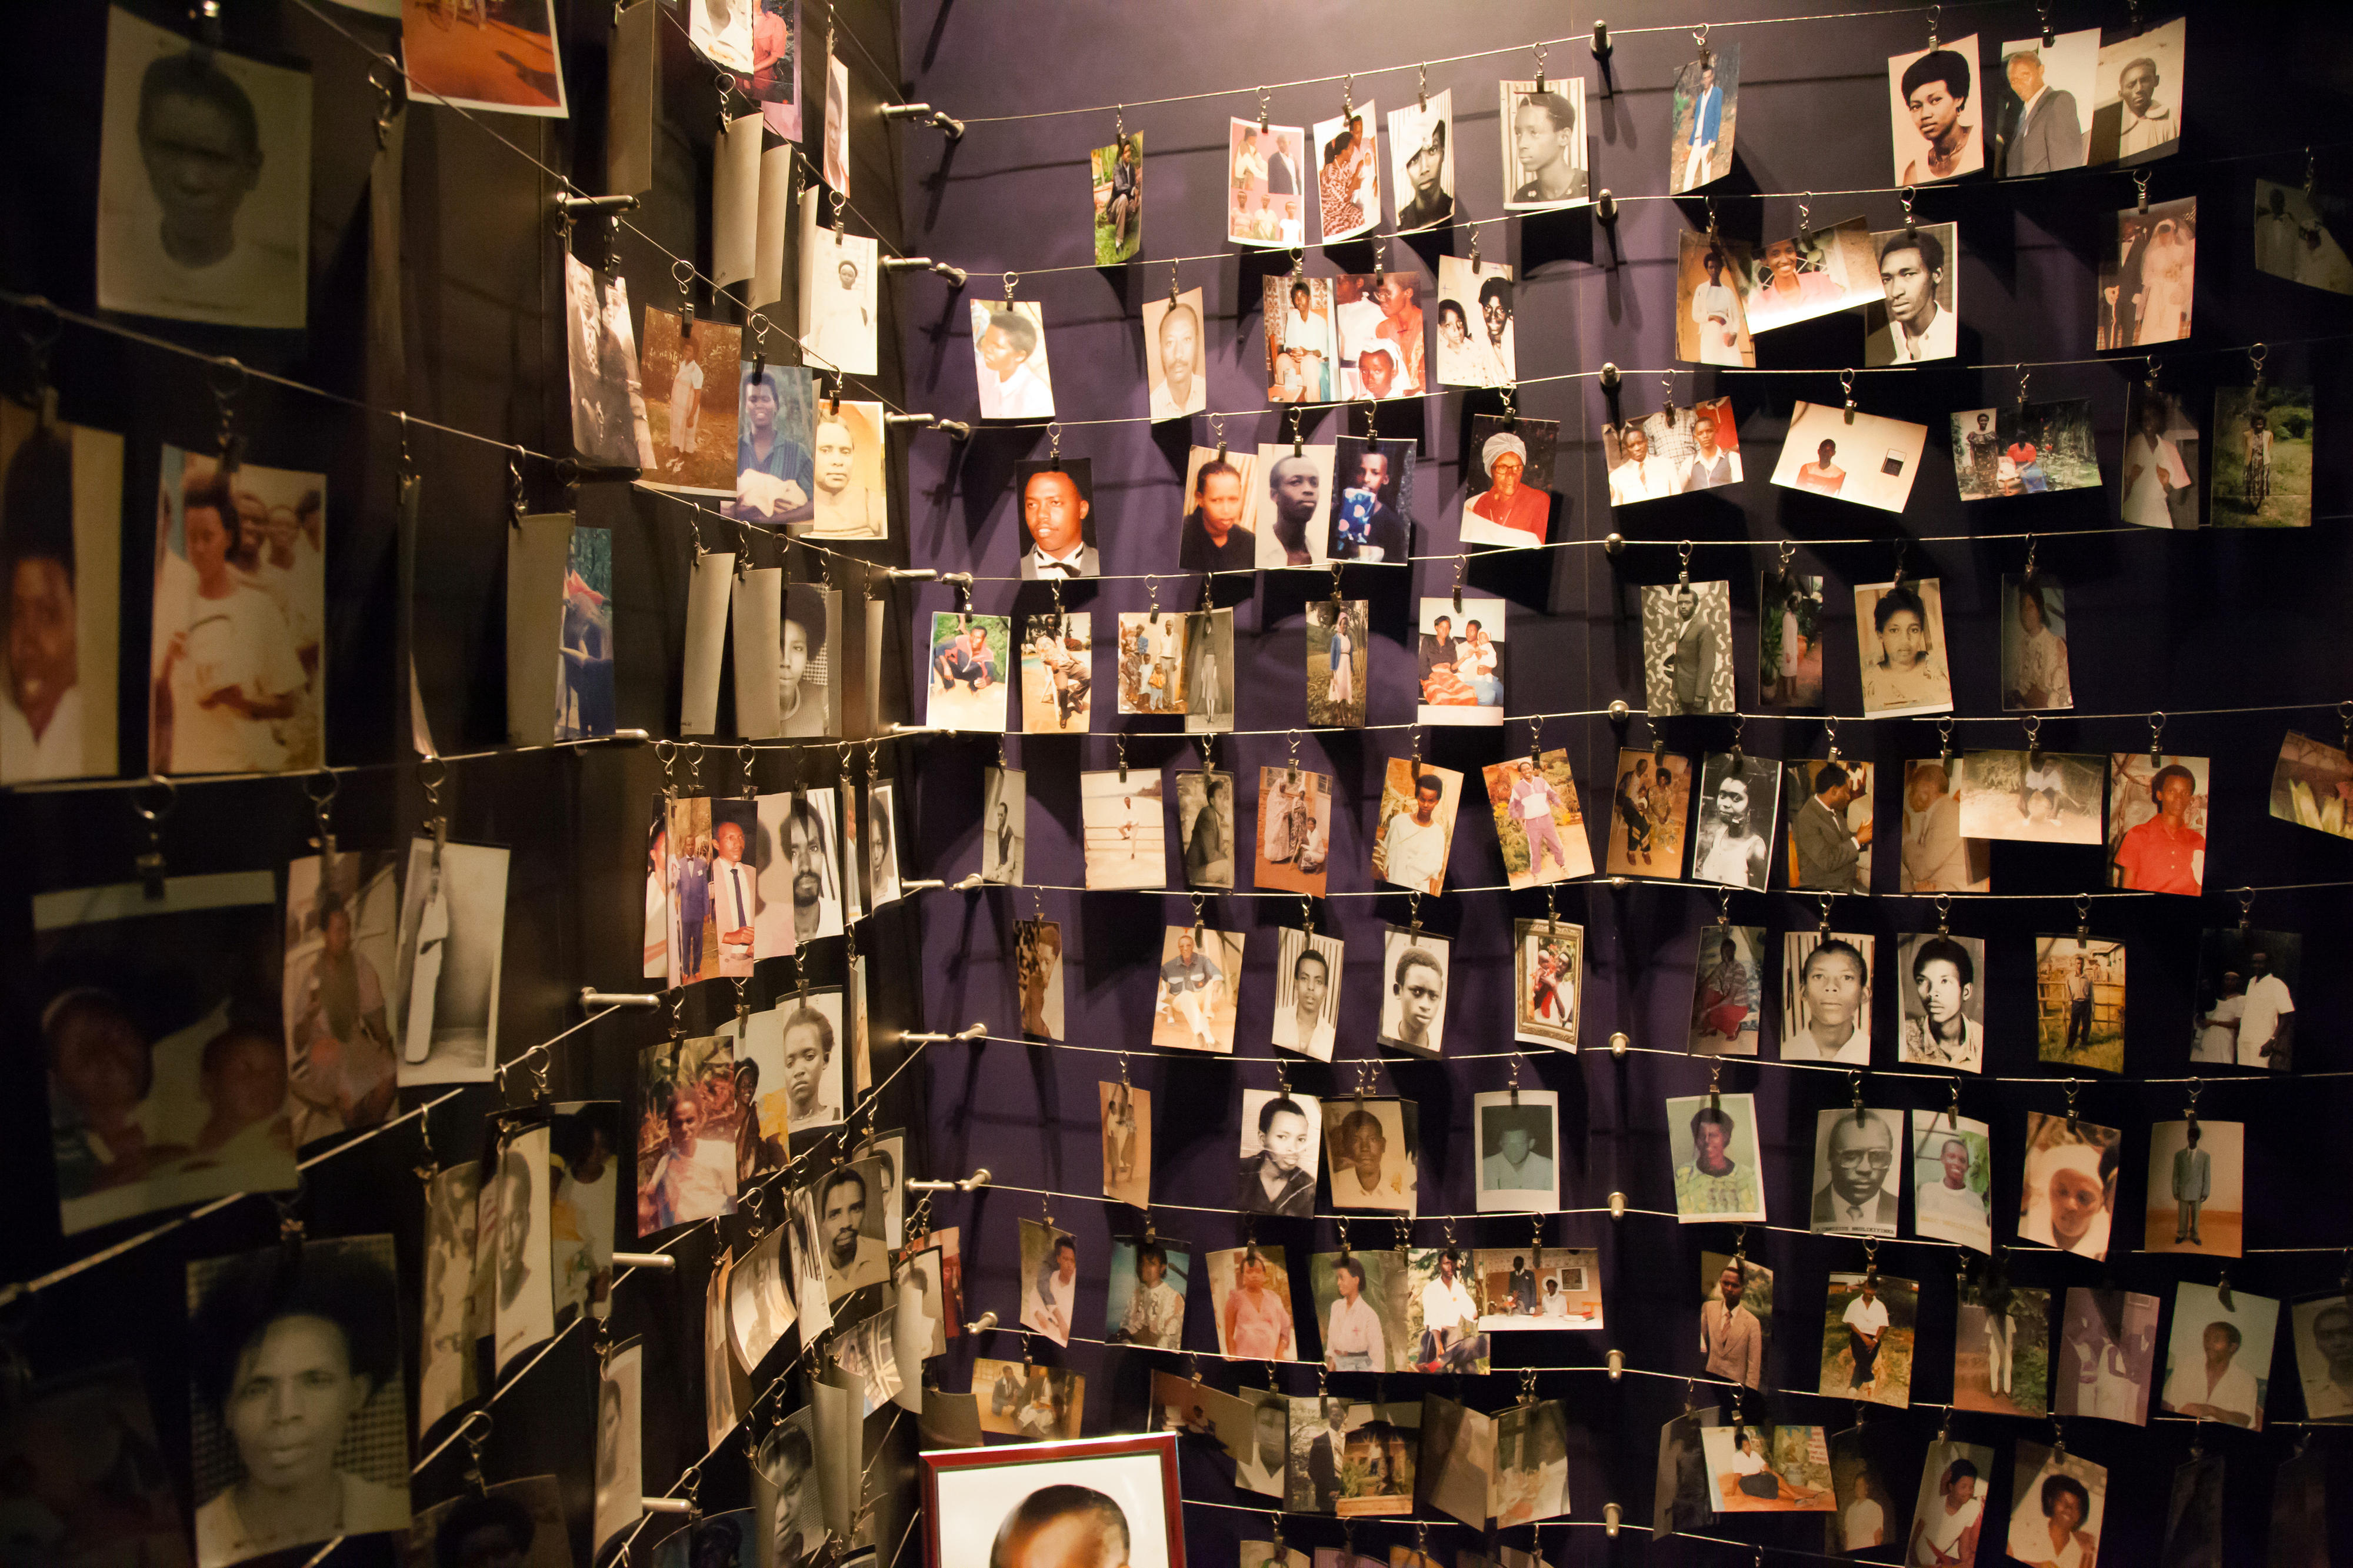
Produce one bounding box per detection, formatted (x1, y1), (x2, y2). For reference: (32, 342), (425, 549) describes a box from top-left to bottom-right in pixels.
(146, 445), (327, 775)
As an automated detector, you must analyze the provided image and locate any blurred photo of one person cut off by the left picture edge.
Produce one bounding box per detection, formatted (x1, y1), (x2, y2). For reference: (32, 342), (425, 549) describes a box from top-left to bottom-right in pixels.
(0, 402), (122, 784)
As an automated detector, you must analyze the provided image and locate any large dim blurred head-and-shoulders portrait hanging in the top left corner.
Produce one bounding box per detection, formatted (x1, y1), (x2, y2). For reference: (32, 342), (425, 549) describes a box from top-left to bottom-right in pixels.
(96, 7), (311, 327)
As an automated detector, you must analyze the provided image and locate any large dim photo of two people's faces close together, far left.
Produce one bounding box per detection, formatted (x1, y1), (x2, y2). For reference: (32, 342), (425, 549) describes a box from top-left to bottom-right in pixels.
(31, 871), (296, 1236)
